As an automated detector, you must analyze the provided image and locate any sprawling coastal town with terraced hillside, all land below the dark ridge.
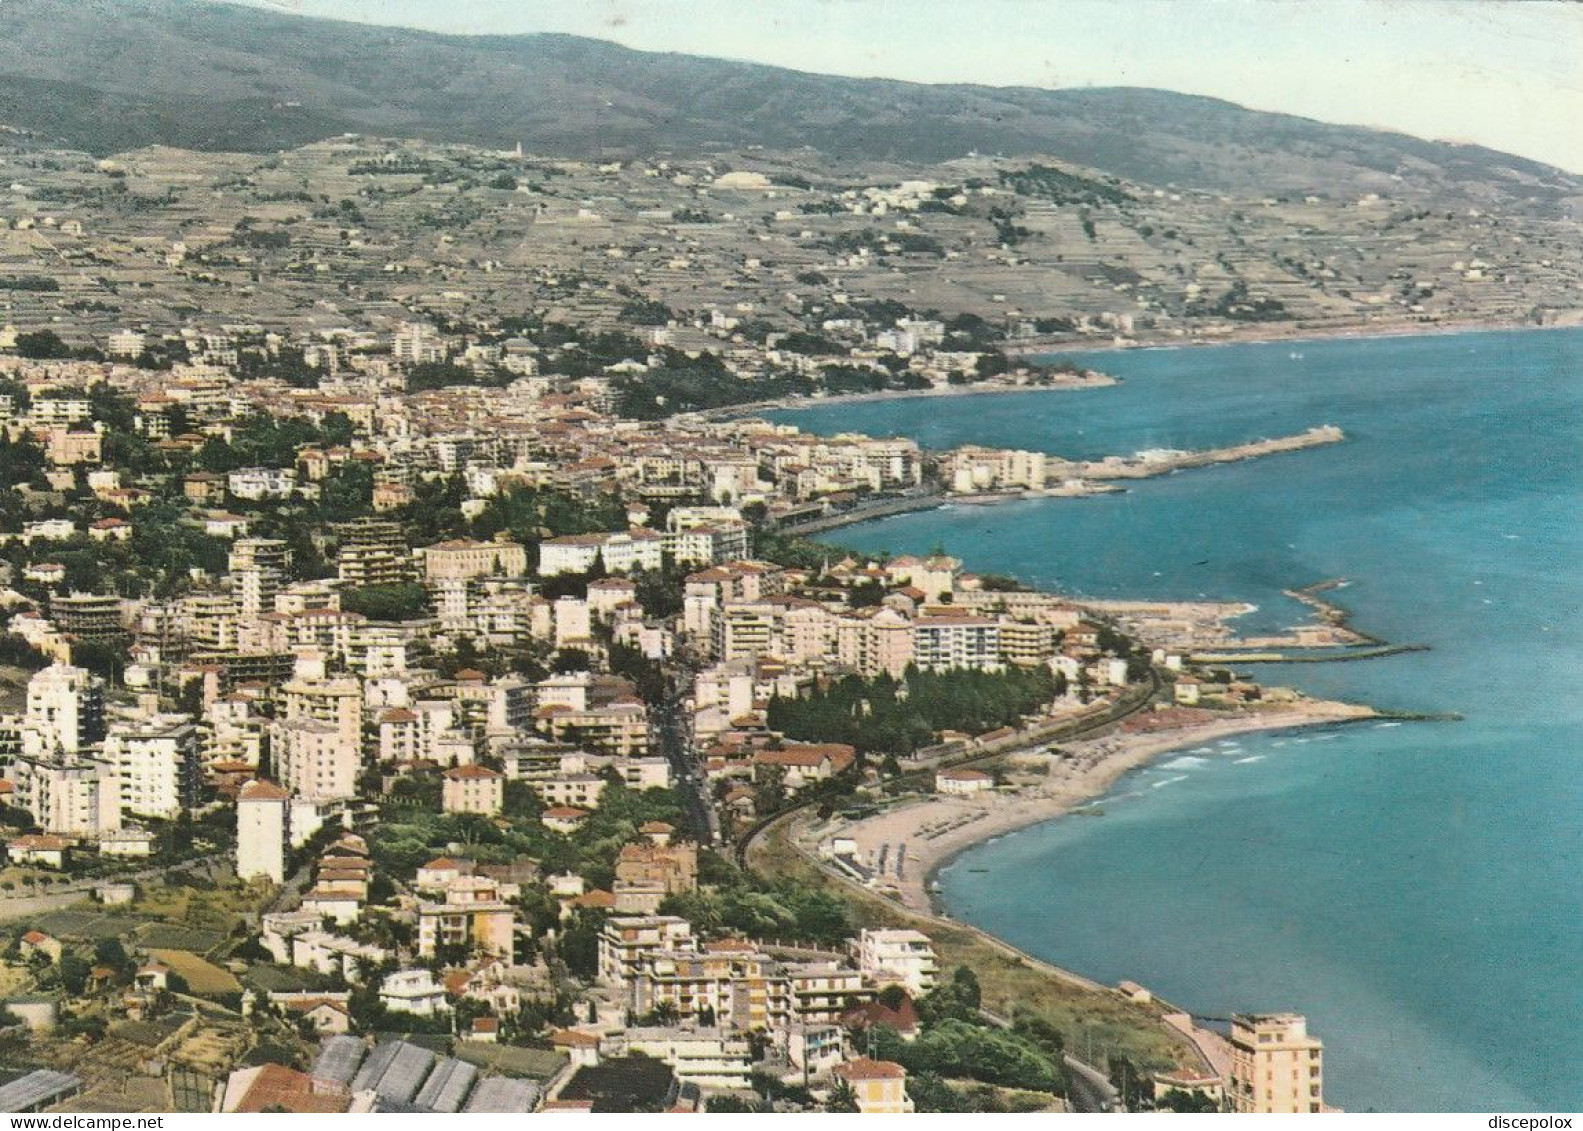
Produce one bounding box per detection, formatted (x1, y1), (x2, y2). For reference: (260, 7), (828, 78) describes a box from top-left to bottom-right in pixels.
(0, 123), (1551, 1112)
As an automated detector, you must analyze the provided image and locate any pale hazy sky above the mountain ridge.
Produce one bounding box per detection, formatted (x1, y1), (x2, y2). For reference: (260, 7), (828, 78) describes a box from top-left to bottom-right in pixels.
(229, 0), (1583, 173)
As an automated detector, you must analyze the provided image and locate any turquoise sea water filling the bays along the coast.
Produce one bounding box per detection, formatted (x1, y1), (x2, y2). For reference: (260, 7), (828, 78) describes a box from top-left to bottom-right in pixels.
(777, 331), (1583, 1110)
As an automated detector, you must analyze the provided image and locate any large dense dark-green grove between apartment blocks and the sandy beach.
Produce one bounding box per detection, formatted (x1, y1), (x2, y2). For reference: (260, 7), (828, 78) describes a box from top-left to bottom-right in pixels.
(769, 667), (1065, 756)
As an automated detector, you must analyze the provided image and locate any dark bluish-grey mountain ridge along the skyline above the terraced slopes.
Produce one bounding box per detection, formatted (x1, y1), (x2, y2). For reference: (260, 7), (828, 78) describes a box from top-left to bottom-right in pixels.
(0, 0), (1583, 211)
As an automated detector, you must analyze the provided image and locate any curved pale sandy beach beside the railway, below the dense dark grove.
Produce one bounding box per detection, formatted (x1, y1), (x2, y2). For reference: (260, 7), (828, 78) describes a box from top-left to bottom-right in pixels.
(796, 700), (1377, 914)
